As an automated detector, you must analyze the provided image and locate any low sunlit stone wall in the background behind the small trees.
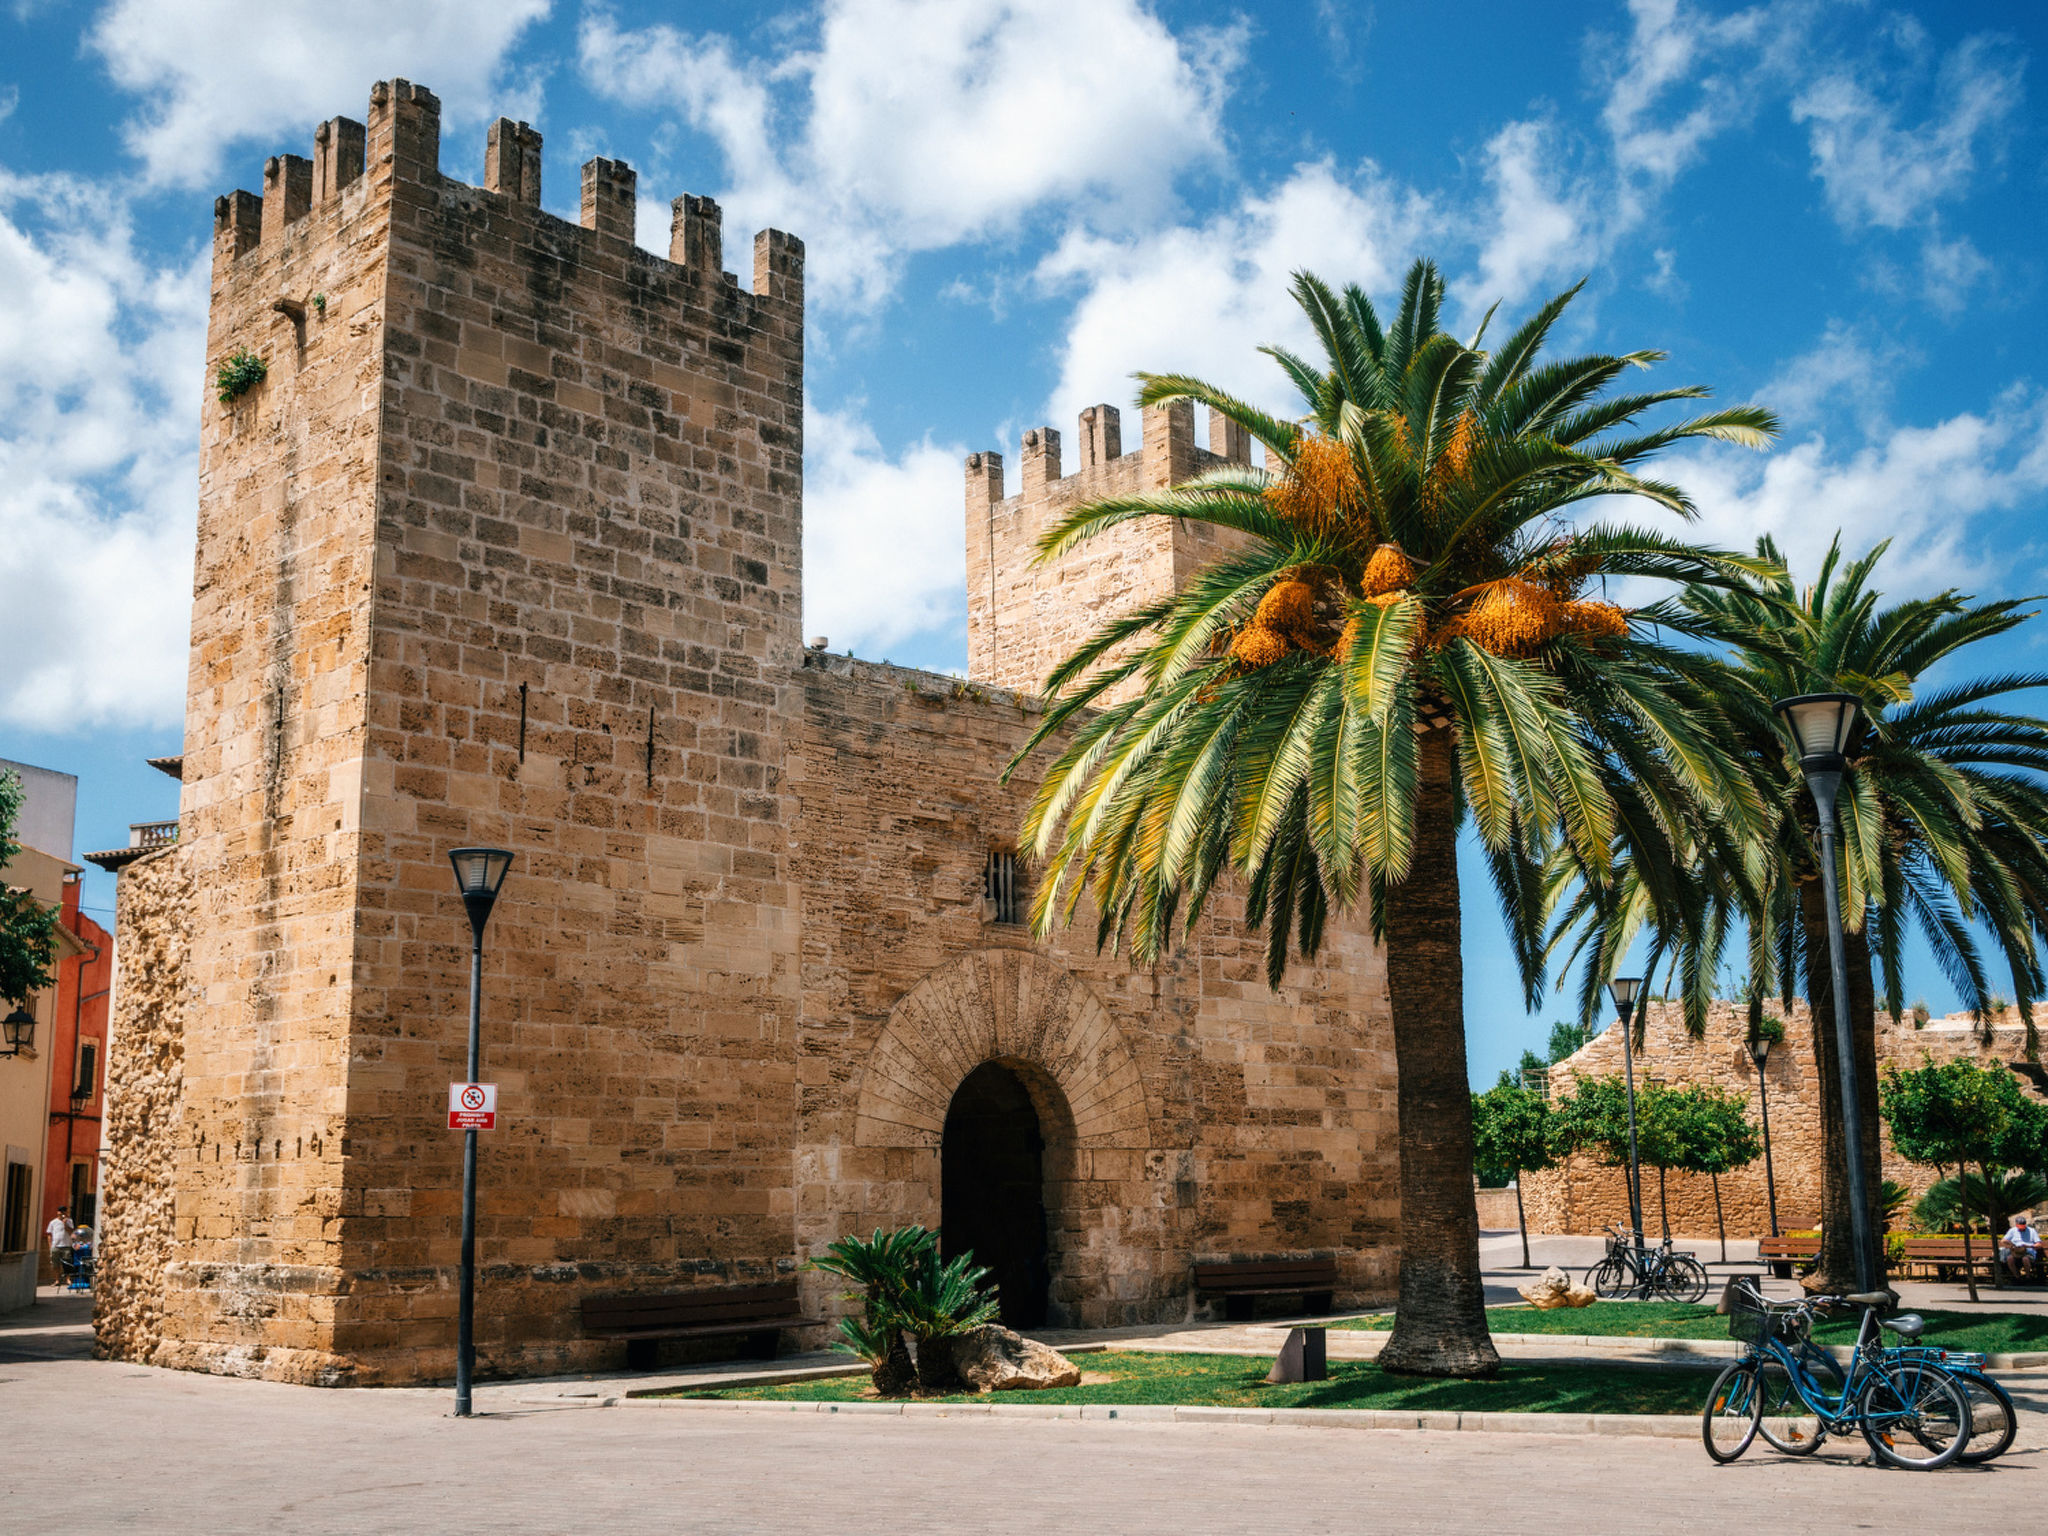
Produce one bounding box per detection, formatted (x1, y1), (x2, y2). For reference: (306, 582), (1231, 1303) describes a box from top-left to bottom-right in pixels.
(1522, 1004), (2025, 1239)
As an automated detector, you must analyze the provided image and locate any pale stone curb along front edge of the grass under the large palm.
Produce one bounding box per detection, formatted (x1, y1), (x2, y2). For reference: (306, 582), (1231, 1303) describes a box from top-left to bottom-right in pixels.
(604, 1397), (1700, 1440)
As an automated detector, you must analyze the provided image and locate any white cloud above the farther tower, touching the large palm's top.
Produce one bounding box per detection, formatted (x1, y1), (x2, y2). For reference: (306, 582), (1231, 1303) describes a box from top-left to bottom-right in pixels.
(1038, 160), (1438, 436)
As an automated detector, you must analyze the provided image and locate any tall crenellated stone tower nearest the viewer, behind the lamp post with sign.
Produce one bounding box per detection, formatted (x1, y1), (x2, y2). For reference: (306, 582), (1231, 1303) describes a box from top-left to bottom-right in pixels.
(123, 80), (803, 1380)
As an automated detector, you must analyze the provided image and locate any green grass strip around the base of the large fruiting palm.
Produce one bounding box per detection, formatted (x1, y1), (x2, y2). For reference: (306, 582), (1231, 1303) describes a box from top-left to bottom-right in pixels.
(676, 1350), (1712, 1413)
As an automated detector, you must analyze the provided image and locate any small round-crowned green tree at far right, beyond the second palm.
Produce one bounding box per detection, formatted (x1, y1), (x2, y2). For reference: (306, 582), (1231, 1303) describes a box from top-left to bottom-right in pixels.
(1878, 1059), (2042, 1300)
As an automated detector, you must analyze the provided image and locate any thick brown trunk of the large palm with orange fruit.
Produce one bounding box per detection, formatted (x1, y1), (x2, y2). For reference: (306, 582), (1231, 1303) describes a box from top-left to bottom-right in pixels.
(1378, 729), (1501, 1376)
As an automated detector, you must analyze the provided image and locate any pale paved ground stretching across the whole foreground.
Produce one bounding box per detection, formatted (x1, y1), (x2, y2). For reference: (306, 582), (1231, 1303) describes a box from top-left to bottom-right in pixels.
(0, 1309), (2048, 1536)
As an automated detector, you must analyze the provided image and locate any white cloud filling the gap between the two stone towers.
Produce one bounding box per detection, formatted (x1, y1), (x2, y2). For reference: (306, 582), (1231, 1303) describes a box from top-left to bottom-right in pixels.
(803, 408), (967, 655)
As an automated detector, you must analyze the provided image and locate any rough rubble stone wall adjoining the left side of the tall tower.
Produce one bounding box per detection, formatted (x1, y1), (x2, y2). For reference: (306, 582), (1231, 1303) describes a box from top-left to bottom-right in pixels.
(92, 848), (193, 1360)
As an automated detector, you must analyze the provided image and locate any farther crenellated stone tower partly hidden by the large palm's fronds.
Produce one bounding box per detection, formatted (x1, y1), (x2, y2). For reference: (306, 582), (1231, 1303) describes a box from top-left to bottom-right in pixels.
(967, 399), (1251, 698)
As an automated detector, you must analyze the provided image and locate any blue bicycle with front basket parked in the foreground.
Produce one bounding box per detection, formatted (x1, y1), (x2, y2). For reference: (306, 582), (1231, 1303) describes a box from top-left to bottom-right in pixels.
(1700, 1282), (1974, 1470)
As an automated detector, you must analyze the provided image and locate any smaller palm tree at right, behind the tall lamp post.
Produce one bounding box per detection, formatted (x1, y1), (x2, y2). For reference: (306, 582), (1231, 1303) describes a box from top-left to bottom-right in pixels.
(1552, 539), (2048, 1288)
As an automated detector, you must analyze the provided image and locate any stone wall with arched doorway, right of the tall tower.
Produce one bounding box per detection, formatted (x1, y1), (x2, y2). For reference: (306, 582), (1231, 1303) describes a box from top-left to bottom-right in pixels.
(791, 653), (1399, 1327)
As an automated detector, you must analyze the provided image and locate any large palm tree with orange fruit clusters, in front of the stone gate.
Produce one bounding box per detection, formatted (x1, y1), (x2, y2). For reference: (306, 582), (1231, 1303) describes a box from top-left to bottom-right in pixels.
(1018, 262), (1774, 1376)
